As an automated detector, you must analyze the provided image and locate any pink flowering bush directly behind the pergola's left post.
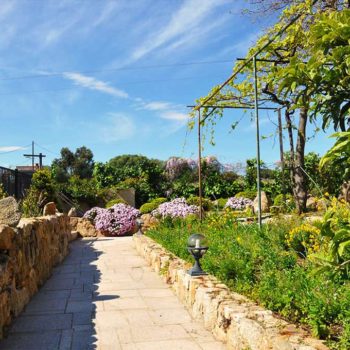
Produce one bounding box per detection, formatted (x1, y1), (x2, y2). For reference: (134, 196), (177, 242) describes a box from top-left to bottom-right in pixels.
(152, 198), (199, 218)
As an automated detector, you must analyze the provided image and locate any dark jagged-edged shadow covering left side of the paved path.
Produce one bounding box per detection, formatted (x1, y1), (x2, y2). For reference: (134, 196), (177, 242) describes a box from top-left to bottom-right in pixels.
(0, 238), (119, 350)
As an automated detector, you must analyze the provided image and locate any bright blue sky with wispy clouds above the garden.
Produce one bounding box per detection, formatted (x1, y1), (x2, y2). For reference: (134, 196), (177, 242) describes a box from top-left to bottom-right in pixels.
(0, 0), (332, 167)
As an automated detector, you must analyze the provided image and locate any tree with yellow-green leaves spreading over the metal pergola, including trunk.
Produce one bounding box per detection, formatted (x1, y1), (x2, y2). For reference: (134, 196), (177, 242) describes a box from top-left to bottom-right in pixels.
(191, 0), (350, 212)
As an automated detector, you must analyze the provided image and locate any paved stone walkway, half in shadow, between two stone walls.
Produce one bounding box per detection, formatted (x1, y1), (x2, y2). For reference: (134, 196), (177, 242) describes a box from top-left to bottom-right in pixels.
(0, 237), (224, 350)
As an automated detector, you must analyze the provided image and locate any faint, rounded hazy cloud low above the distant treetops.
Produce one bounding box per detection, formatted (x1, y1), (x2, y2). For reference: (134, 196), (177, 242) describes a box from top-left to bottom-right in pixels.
(97, 113), (136, 143)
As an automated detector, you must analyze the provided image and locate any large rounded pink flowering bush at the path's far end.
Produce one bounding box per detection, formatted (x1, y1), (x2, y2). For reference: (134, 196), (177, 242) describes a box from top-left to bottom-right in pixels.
(84, 203), (140, 236)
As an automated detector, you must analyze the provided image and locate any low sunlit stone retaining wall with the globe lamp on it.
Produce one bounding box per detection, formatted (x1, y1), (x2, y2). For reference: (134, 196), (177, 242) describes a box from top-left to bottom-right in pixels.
(133, 235), (328, 350)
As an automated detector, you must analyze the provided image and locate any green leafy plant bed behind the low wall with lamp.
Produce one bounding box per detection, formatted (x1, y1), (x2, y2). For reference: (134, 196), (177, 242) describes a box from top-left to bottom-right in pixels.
(147, 213), (350, 349)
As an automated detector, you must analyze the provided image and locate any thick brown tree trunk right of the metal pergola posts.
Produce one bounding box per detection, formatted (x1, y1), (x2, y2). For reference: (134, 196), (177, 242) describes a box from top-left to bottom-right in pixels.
(294, 108), (308, 214)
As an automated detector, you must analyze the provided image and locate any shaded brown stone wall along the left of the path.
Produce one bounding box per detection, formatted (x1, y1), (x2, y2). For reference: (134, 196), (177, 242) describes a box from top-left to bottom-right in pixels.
(0, 214), (71, 339)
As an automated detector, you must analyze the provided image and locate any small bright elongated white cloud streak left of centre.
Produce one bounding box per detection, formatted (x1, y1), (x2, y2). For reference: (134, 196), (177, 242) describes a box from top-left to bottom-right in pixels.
(64, 72), (129, 98)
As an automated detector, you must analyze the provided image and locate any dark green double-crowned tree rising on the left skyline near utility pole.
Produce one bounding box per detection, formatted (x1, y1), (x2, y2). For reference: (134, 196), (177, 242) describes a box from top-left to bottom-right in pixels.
(52, 146), (94, 183)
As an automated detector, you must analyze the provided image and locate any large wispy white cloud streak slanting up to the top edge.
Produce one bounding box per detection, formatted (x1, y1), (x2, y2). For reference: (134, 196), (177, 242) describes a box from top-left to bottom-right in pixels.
(131, 0), (226, 60)
